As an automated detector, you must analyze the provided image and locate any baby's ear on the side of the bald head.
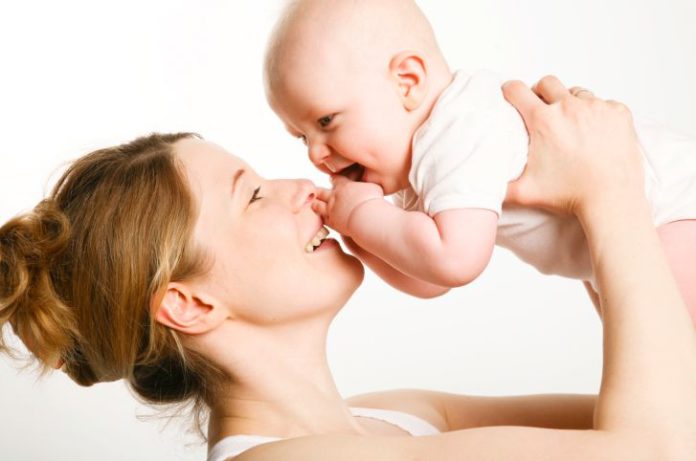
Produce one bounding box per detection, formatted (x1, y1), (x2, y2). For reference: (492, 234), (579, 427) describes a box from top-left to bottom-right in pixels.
(389, 51), (428, 111)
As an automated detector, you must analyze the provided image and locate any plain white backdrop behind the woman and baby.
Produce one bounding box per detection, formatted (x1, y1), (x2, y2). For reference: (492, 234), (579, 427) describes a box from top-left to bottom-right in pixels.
(0, 0), (696, 461)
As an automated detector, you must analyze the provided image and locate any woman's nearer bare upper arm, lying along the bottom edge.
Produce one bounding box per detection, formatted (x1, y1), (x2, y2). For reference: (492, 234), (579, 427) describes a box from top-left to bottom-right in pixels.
(239, 426), (648, 461)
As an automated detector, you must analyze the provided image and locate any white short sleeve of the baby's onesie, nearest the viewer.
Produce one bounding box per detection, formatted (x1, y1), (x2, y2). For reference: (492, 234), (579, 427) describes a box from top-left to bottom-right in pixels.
(409, 71), (528, 216)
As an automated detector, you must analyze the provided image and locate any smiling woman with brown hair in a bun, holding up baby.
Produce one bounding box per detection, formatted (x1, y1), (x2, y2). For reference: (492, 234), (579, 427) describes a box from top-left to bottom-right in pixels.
(0, 79), (696, 460)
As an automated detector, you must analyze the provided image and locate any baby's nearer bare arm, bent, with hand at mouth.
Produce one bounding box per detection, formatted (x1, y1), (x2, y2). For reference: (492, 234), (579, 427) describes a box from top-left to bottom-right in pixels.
(316, 176), (498, 287)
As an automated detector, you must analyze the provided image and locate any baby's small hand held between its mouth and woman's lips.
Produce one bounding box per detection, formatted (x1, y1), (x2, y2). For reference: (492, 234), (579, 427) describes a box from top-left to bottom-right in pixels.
(312, 175), (384, 236)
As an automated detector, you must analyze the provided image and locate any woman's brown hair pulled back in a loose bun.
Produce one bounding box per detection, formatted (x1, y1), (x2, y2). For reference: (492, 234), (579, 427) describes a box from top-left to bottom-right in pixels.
(0, 133), (218, 430)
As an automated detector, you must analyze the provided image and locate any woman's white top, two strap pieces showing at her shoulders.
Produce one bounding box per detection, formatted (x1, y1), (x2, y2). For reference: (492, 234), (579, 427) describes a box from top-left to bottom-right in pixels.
(208, 408), (440, 461)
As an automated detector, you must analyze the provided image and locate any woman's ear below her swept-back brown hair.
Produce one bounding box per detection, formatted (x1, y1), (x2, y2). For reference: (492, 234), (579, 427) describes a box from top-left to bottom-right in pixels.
(154, 282), (228, 335)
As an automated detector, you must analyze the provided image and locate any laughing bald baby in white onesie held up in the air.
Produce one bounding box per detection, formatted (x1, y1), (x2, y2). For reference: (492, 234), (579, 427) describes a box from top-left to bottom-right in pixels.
(265, 0), (696, 318)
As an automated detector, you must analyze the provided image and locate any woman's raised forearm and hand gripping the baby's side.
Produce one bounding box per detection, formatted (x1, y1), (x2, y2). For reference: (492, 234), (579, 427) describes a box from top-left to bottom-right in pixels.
(505, 78), (696, 440)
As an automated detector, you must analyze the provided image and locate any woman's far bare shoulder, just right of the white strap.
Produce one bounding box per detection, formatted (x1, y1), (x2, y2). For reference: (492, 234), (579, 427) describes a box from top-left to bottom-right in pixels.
(346, 389), (449, 432)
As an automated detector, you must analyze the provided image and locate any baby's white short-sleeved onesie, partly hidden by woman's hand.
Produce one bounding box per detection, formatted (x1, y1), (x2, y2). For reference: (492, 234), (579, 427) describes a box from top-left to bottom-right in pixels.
(394, 71), (696, 281)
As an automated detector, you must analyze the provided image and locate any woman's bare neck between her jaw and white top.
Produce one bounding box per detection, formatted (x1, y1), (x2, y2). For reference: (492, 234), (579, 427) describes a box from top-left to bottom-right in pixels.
(208, 318), (362, 445)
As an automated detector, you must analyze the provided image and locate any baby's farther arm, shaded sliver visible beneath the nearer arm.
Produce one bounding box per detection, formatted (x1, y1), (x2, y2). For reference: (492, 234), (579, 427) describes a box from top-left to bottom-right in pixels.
(343, 236), (449, 298)
